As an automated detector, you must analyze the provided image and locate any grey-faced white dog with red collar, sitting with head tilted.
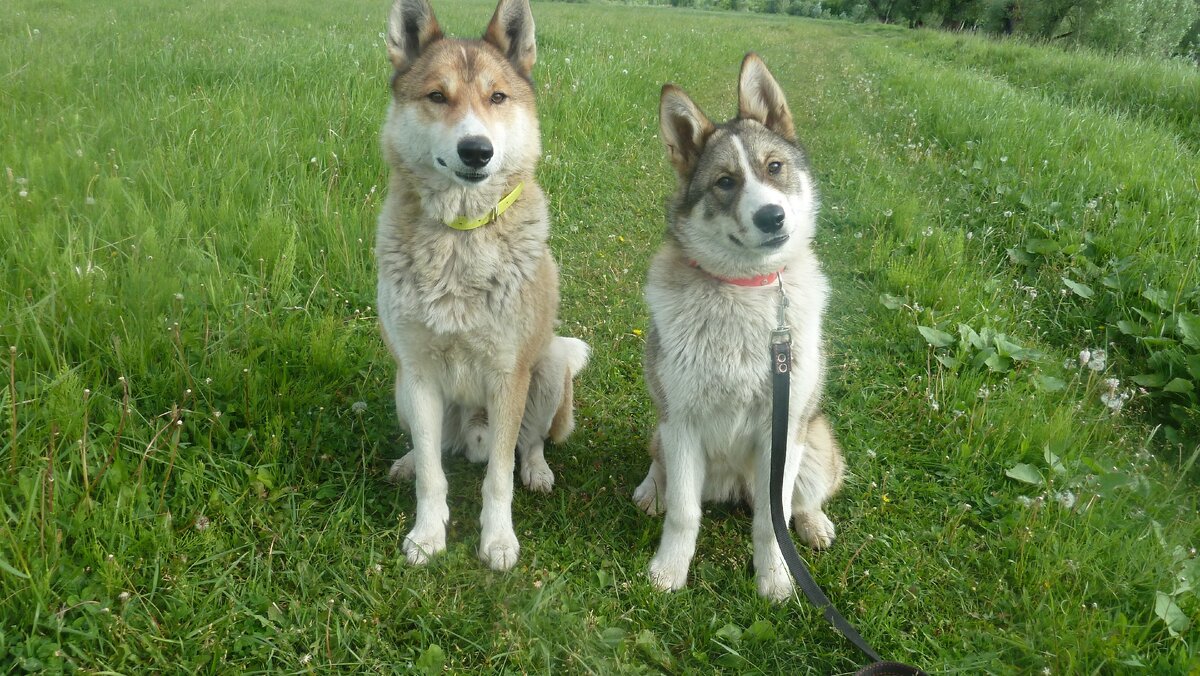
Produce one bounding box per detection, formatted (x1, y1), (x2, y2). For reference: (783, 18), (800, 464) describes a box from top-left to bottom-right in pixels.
(634, 54), (844, 600)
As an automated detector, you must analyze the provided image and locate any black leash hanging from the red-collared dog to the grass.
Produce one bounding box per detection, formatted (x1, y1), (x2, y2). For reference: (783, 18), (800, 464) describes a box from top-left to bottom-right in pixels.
(770, 276), (925, 676)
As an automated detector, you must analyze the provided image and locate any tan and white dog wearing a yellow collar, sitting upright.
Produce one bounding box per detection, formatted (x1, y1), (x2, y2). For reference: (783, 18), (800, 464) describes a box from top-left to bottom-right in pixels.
(376, 0), (588, 570)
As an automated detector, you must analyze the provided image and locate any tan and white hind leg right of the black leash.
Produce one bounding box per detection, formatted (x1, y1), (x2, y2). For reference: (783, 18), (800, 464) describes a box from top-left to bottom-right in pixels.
(792, 414), (845, 549)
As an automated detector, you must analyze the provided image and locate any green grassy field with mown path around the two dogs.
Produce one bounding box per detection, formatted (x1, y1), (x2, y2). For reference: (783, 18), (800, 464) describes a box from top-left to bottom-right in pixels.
(0, 0), (1200, 674)
